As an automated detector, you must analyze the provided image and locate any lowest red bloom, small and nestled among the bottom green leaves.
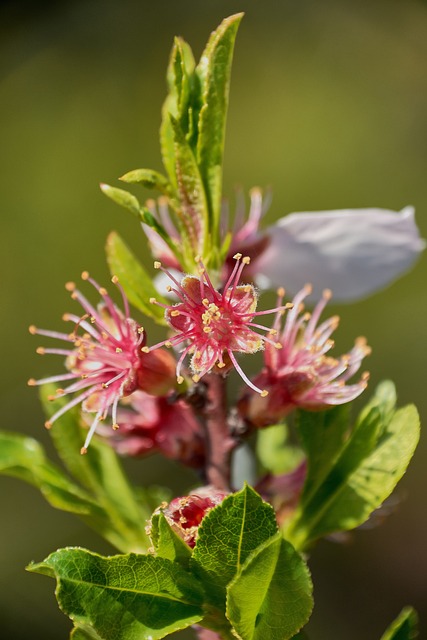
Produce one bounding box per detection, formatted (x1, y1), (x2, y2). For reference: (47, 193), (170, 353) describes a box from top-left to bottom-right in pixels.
(147, 486), (228, 549)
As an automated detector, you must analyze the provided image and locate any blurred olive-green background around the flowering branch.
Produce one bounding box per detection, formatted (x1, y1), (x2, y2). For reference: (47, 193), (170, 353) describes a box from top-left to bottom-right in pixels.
(0, 0), (427, 640)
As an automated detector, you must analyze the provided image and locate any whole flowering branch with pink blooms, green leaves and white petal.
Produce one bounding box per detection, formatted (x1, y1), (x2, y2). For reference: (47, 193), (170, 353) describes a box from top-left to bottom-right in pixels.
(18, 14), (424, 640)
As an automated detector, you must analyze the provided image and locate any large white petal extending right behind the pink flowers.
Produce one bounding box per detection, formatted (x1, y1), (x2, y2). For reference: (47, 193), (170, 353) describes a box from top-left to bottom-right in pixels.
(256, 207), (426, 301)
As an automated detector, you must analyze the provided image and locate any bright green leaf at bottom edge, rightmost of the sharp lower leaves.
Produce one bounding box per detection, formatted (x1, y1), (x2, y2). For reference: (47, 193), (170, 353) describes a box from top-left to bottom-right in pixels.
(227, 533), (313, 640)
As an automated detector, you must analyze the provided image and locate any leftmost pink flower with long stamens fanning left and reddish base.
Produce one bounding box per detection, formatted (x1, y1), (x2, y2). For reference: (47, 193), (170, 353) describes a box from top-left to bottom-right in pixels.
(28, 272), (175, 453)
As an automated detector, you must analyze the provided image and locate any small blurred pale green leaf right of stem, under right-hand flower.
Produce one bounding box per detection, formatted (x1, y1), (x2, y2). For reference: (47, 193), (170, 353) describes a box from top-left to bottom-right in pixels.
(256, 424), (303, 475)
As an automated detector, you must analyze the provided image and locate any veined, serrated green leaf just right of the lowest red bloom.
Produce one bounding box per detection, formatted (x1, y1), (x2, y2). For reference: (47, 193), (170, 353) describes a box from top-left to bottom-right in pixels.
(190, 486), (277, 608)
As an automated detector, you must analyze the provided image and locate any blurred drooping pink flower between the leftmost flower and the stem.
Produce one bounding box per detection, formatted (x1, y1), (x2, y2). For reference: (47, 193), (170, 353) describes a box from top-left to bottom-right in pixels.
(99, 390), (205, 467)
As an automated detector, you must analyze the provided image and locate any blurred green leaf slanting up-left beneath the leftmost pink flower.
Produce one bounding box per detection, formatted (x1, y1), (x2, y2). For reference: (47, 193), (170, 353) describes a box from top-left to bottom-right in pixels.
(40, 385), (151, 551)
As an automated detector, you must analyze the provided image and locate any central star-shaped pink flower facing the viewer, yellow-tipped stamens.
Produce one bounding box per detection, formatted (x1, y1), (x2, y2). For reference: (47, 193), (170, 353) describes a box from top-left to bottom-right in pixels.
(147, 253), (290, 396)
